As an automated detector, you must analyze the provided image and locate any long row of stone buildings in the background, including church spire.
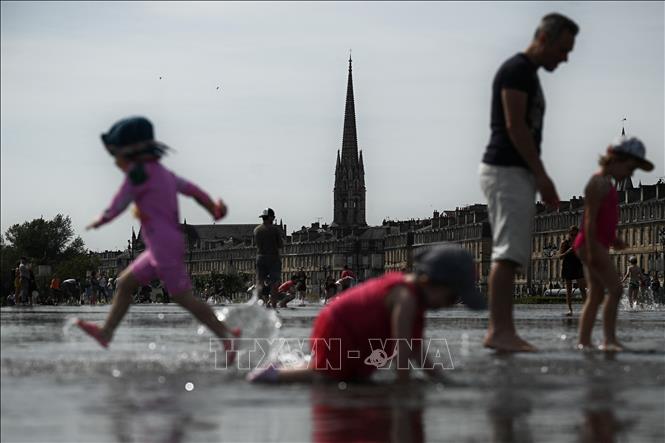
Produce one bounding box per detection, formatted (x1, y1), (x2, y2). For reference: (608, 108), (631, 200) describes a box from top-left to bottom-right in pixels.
(96, 55), (665, 295)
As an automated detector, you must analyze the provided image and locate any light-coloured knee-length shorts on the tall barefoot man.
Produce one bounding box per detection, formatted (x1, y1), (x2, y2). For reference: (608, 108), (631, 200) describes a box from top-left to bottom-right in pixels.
(478, 163), (536, 269)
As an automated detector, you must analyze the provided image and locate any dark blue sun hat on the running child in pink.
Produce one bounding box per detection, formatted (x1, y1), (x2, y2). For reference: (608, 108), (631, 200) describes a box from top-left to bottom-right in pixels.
(101, 117), (171, 159)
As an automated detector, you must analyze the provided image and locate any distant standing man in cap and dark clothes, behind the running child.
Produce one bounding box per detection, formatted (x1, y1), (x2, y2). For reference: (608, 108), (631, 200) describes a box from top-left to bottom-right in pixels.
(254, 208), (284, 308)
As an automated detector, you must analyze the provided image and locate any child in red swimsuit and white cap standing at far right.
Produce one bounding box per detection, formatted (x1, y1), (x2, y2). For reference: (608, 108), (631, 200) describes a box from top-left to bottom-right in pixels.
(574, 136), (653, 352)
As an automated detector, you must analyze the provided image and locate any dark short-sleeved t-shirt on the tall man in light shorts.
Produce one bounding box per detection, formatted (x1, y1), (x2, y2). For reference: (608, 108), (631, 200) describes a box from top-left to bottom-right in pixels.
(483, 53), (545, 168)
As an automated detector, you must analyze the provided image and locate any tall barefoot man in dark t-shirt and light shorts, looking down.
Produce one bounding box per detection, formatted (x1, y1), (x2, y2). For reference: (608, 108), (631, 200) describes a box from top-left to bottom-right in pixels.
(479, 13), (579, 352)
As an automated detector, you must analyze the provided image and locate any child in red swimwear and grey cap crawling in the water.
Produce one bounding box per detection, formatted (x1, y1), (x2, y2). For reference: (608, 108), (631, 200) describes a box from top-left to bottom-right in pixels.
(247, 246), (485, 382)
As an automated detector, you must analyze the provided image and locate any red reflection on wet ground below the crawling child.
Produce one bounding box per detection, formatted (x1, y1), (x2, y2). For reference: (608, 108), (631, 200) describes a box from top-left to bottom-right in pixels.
(311, 383), (422, 443)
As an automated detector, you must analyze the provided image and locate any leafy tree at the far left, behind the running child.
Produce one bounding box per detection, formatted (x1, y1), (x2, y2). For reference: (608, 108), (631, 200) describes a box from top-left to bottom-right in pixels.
(5, 214), (85, 265)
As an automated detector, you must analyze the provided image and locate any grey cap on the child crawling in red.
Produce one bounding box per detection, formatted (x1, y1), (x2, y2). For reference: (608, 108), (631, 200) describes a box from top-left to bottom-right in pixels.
(414, 245), (487, 310)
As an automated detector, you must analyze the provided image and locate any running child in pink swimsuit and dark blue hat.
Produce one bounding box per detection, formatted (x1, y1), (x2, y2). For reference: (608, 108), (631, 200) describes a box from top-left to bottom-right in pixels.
(76, 117), (239, 348)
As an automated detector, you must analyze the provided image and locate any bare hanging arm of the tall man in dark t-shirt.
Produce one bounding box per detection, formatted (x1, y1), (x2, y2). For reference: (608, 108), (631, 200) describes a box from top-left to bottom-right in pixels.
(501, 89), (559, 207)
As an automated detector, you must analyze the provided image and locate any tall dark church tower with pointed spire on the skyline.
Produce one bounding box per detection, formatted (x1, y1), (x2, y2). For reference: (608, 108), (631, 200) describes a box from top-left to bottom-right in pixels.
(332, 56), (367, 228)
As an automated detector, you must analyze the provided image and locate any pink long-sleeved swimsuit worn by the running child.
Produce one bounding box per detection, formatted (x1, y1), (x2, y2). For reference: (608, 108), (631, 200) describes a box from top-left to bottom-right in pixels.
(99, 161), (213, 294)
